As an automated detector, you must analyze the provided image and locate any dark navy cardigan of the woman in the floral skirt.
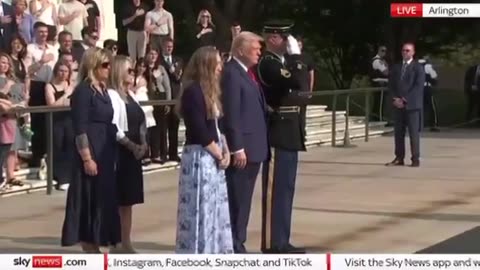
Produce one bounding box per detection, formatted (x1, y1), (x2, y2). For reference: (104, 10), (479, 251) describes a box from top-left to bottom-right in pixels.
(180, 83), (219, 147)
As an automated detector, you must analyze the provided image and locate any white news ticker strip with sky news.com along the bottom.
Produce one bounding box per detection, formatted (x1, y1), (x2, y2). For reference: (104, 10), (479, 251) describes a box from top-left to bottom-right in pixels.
(4, 254), (480, 270)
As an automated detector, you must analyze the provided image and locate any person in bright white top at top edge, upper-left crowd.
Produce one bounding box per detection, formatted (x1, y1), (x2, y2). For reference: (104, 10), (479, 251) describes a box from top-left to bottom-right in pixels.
(29, 0), (58, 43)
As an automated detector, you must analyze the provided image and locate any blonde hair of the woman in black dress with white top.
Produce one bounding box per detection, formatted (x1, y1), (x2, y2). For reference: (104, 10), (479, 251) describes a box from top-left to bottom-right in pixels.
(107, 55), (132, 103)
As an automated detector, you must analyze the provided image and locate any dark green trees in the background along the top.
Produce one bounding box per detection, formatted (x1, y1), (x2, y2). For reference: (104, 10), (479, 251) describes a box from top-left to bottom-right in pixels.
(166, 0), (480, 89)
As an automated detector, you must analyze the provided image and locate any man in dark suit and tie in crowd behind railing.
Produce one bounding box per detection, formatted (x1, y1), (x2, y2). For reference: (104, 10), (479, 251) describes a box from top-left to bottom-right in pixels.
(159, 37), (183, 162)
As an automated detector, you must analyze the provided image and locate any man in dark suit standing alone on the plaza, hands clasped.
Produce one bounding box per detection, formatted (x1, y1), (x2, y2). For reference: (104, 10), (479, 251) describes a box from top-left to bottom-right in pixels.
(386, 43), (425, 167)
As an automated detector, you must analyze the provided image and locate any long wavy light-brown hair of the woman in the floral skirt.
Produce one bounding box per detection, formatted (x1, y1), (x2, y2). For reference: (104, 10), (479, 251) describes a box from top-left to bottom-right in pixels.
(176, 46), (223, 119)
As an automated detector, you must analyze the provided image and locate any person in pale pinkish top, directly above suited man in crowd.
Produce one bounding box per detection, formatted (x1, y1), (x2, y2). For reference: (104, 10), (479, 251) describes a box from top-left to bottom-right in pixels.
(145, 0), (174, 50)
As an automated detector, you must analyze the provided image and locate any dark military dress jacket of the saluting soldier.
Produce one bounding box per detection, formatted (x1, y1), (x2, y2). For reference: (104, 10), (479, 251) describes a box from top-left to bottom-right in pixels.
(256, 51), (309, 151)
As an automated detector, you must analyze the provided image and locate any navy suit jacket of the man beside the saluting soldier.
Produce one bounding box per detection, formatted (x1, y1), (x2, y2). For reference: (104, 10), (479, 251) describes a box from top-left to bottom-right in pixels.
(221, 59), (268, 162)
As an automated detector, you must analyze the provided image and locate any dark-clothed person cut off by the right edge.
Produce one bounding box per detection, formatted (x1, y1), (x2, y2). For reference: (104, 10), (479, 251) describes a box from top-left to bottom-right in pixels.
(463, 65), (480, 122)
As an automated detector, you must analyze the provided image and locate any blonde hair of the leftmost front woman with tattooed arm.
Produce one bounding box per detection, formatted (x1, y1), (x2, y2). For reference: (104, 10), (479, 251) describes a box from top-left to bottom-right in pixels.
(77, 48), (112, 83)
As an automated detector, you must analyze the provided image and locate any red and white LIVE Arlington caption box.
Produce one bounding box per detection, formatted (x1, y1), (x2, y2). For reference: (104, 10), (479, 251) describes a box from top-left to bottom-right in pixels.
(390, 3), (480, 18)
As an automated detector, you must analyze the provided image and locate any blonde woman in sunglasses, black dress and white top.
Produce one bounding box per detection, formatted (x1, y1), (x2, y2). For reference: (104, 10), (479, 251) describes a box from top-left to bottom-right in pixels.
(108, 56), (148, 253)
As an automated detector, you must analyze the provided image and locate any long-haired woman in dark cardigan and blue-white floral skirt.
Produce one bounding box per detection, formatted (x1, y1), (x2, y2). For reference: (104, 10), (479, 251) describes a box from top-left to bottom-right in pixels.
(176, 47), (233, 254)
